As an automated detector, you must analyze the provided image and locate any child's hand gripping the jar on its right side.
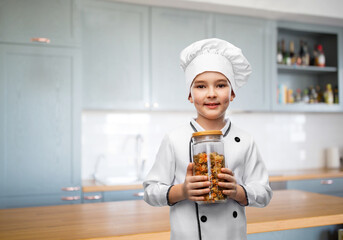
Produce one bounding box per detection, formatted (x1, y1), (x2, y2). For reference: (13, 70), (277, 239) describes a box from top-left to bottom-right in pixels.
(218, 168), (248, 205)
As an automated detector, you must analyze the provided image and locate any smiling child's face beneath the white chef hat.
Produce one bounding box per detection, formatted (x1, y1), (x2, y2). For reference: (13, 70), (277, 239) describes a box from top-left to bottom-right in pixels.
(188, 72), (235, 120)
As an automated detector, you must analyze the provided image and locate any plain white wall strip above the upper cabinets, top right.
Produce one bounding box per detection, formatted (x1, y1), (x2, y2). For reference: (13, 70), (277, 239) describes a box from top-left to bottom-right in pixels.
(118, 0), (343, 26)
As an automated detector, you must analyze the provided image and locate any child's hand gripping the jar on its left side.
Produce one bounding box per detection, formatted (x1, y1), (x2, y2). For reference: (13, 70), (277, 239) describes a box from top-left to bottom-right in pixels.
(182, 163), (210, 201)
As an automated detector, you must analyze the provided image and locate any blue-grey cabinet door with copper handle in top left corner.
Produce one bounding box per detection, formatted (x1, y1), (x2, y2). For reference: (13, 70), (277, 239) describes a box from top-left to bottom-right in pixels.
(0, 0), (80, 46)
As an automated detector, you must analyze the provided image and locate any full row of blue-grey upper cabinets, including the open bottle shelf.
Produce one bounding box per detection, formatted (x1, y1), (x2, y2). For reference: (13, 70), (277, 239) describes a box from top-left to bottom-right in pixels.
(81, 0), (343, 112)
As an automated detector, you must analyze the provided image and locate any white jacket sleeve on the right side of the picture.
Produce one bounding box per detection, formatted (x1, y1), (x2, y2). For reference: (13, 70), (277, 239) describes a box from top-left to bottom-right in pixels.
(243, 139), (273, 207)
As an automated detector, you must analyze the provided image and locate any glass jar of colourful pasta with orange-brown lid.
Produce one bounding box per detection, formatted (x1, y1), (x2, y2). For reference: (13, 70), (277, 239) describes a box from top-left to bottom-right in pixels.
(192, 131), (227, 204)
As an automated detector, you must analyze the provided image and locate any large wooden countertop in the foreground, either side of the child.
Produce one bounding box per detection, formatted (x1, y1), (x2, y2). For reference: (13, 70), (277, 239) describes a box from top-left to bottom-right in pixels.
(0, 190), (343, 240)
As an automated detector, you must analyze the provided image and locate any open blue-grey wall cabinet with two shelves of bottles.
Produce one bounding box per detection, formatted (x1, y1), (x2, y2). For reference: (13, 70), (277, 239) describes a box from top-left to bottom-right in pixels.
(272, 22), (343, 112)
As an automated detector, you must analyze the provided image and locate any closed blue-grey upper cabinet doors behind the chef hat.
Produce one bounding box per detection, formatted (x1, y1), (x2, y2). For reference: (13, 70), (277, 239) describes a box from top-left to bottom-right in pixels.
(82, 1), (272, 111)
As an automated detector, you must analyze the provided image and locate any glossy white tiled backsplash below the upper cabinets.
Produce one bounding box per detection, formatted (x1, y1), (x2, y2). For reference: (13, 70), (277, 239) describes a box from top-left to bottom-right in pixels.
(82, 111), (343, 179)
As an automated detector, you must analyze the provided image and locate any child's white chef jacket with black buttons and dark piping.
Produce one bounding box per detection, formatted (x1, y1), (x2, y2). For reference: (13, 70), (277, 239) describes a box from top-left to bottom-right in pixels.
(143, 118), (272, 240)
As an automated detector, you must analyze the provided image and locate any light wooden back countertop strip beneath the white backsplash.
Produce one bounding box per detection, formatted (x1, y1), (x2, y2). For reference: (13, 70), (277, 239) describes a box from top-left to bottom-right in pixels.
(82, 169), (343, 193)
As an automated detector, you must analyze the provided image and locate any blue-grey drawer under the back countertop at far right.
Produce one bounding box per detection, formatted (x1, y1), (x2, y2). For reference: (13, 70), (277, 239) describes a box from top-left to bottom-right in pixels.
(287, 178), (343, 195)
